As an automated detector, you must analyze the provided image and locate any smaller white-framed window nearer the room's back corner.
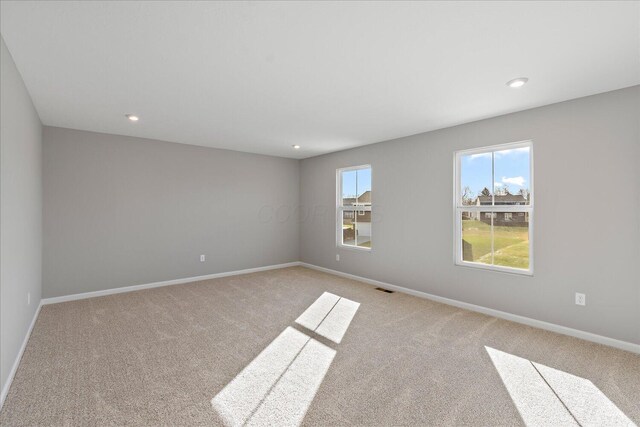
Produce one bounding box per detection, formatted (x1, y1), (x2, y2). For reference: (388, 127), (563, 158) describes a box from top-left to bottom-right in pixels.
(336, 165), (371, 250)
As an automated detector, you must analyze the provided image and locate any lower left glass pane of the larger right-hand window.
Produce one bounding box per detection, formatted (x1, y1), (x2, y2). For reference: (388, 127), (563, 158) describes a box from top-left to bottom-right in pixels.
(461, 211), (491, 264)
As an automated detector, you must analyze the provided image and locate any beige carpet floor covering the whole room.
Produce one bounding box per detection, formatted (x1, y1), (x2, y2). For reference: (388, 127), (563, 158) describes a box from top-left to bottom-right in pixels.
(0, 267), (640, 426)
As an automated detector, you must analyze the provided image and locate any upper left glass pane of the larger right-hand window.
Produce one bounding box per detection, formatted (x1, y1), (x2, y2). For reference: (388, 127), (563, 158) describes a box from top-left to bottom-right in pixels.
(458, 152), (493, 205)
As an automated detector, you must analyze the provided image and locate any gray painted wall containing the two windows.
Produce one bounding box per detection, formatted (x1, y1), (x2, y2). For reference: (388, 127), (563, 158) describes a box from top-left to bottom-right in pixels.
(300, 86), (640, 343)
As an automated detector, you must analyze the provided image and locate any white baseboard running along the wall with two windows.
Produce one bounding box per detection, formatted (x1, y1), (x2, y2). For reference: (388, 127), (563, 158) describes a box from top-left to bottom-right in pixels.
(300, 262), (640, 354)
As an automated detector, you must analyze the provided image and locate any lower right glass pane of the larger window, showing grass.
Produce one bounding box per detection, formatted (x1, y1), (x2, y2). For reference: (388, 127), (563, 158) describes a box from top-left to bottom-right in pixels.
(493, 216), (529, 270)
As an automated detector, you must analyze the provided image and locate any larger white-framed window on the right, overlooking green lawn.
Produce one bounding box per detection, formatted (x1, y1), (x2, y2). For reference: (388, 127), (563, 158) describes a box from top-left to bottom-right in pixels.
(454, 141), (533, 274)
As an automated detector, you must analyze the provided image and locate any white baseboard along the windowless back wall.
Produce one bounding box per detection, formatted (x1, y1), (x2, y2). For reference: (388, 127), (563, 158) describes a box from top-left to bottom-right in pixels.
(42, 261), (300, 305)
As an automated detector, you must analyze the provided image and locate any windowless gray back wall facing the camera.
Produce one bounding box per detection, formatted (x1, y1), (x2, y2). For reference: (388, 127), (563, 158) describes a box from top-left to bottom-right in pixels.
(43, 128), (299, 297)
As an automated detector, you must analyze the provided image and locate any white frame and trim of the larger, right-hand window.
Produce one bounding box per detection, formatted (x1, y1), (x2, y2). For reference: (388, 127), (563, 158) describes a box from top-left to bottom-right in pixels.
(453, 140), (535, 276)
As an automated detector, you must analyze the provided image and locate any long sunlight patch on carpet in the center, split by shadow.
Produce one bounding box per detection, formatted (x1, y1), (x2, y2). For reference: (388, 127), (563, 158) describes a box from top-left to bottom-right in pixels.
(211, 292), (360, 426)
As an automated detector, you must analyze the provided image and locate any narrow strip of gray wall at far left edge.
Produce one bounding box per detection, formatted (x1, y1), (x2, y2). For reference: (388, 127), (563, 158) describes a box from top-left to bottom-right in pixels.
(0, 39), (42, 386)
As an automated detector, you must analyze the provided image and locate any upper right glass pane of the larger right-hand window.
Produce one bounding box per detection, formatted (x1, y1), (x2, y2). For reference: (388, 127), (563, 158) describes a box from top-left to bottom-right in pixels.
(493, 147), (531, 205)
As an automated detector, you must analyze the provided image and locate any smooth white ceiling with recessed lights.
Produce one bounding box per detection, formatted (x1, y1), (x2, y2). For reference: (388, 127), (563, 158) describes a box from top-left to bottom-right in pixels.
(0, 1), (640, 158)
